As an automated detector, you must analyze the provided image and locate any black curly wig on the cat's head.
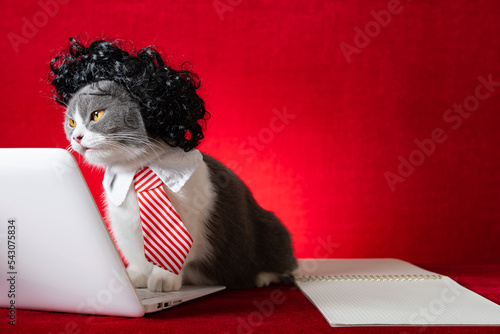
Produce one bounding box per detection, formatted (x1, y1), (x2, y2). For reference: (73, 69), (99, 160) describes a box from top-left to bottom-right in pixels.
(49, 37), (210, 152)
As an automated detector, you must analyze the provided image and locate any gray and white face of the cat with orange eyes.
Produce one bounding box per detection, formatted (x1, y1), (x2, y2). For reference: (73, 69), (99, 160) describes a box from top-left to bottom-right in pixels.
(64, 81), (153, 166)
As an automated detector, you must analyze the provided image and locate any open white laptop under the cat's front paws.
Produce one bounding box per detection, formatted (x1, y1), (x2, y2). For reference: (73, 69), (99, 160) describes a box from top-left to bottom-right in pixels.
(0, 149), (224, 317)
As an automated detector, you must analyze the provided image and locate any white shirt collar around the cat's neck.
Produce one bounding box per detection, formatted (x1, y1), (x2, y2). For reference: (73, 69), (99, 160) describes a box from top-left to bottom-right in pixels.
(102, 149), (203, 206)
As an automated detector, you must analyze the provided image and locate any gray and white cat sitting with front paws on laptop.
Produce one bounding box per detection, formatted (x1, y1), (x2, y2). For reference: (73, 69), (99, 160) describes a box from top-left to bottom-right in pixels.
(64, 81), (296, 291)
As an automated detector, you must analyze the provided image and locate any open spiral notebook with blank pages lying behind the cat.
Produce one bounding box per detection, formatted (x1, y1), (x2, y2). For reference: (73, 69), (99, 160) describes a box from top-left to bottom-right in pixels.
(295, 259), (500, 326)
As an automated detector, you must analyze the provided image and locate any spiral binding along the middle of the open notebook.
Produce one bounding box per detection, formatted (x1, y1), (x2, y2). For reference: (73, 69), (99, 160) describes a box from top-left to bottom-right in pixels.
(295, 275), (443, 282)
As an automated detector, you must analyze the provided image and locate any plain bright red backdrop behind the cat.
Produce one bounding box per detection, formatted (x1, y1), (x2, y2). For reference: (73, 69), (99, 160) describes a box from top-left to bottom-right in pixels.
(0, 0), (500, 263)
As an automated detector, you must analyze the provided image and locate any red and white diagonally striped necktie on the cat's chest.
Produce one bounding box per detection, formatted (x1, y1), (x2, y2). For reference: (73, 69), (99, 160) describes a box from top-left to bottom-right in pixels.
(134, 167), (193, 274)
